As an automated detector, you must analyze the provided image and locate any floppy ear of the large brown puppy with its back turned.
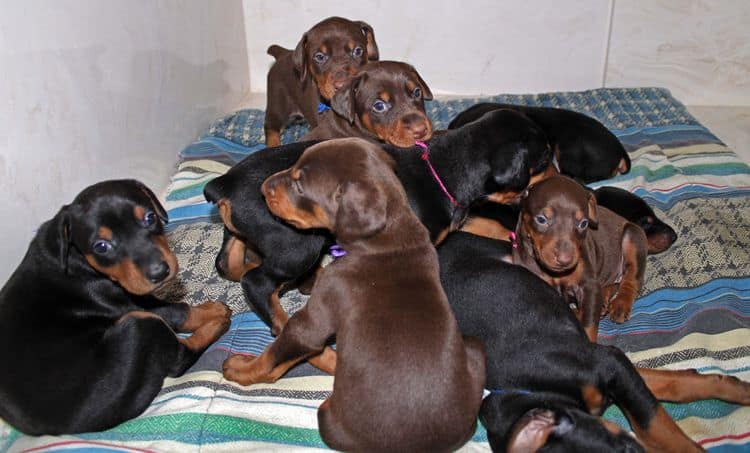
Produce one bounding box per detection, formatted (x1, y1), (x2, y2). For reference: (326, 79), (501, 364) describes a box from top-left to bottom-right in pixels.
(334, 181), (387, 239)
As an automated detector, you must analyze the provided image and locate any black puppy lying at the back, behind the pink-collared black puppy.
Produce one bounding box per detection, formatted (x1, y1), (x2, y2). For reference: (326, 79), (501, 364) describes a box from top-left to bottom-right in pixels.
(448, 103), (630, 183)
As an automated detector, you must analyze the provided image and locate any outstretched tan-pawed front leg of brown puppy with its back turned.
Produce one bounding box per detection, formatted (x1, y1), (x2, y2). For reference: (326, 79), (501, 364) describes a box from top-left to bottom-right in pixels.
(223, 301), (334, 385)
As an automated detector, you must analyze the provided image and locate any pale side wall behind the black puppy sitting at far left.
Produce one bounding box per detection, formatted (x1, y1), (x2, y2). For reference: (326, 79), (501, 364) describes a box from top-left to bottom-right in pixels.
(0, 0), (249, 282)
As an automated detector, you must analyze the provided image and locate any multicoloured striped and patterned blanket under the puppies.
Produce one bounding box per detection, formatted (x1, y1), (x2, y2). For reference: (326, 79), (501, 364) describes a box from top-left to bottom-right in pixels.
(0, 88), (750, 452)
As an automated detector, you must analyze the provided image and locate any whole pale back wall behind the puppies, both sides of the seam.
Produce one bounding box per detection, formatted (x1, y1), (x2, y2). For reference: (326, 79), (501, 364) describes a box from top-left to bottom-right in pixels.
(244, 0), (750, 105)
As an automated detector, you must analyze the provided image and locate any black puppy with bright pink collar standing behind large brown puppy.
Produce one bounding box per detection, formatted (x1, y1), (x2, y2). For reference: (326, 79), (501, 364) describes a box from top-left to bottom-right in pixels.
(204, 110), (551, 334)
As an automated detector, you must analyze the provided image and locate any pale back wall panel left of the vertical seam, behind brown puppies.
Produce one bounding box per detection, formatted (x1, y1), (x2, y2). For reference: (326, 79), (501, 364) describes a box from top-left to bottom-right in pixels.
(245, 0), (610, 94)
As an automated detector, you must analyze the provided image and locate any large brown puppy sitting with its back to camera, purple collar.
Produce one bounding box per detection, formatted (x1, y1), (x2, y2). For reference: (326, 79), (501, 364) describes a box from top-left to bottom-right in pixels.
(224, 138), (485, 451)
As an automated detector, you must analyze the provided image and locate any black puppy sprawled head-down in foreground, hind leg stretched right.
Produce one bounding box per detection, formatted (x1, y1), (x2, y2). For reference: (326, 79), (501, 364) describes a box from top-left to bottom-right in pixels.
(438, 232), (750, 452)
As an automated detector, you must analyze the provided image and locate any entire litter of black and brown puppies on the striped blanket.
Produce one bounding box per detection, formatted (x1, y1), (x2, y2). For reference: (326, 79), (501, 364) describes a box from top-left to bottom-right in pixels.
(0, 17), (750, 452)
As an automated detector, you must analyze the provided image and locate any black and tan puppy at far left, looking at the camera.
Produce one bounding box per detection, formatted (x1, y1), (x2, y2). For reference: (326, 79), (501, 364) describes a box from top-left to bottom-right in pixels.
(0, 180), (231, 435)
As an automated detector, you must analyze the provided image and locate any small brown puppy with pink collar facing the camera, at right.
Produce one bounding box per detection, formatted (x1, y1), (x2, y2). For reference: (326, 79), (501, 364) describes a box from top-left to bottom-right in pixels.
(513, 175), (648, 341)
